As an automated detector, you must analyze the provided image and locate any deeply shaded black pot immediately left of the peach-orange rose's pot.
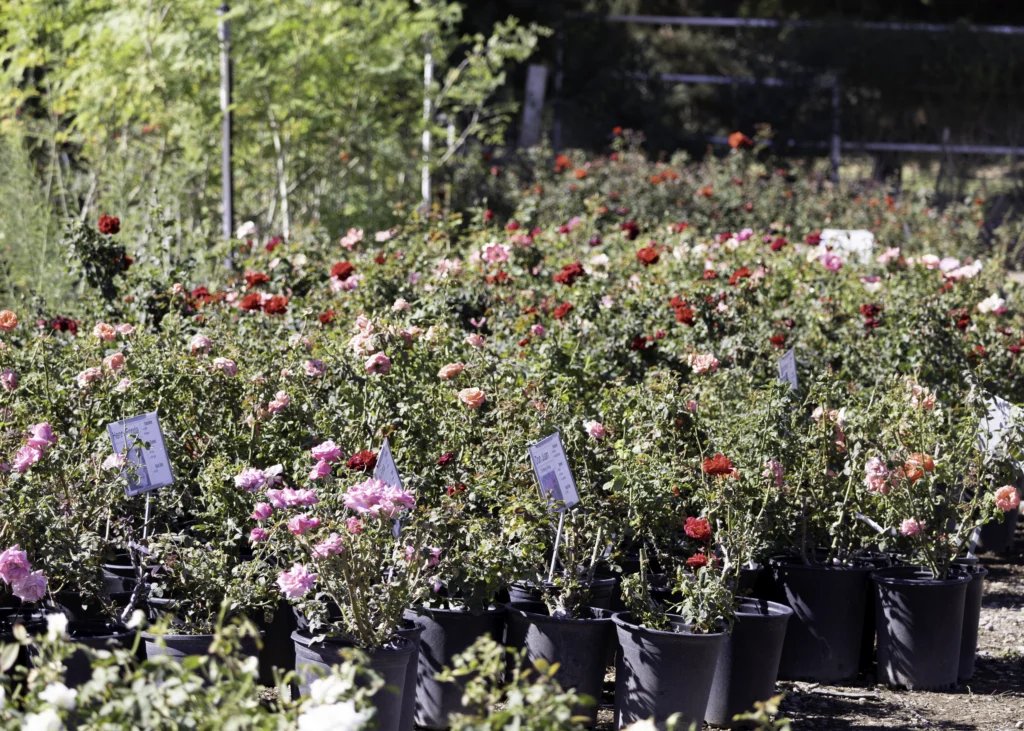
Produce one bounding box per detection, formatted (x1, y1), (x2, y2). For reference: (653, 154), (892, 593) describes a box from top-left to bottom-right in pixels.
(768, 556), (874, 683)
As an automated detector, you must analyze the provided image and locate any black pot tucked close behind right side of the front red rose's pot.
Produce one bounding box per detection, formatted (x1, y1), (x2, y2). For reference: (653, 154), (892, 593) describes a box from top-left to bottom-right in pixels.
(705, 599), (793, 728)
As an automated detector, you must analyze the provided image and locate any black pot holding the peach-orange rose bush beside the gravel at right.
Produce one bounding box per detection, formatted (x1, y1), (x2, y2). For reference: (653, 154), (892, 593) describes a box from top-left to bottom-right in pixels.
(873, 566), (971, 690)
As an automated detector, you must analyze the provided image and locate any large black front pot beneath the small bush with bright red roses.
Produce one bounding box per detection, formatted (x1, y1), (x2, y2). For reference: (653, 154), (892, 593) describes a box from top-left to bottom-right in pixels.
(612, 612), (726, 729)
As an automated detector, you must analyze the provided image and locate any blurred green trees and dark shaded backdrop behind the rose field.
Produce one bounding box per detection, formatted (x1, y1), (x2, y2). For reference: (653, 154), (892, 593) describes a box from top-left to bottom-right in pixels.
(0, 0), (1024, 296)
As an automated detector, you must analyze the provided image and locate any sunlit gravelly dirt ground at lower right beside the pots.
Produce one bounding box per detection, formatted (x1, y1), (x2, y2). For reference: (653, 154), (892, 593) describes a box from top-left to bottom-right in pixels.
(598, 521), (1024, 731)
